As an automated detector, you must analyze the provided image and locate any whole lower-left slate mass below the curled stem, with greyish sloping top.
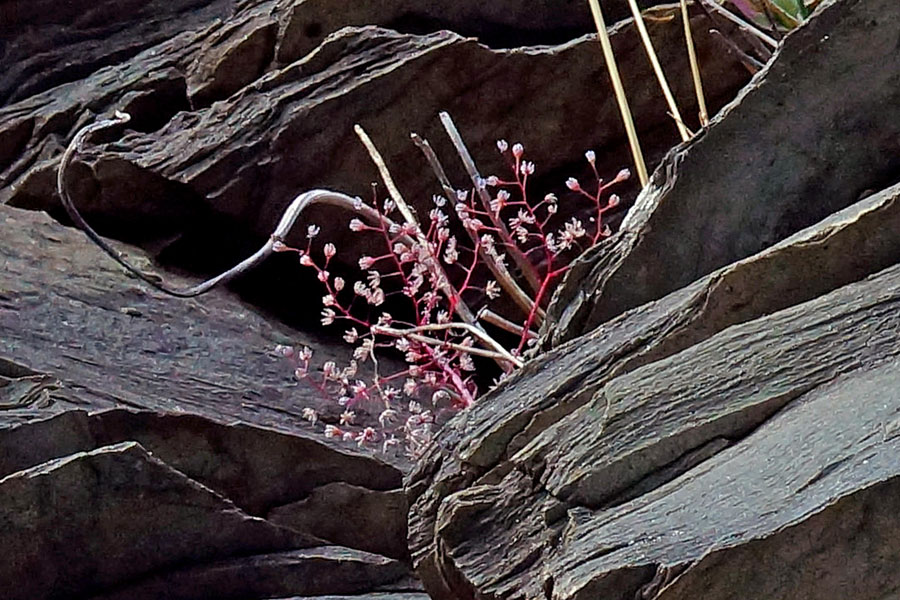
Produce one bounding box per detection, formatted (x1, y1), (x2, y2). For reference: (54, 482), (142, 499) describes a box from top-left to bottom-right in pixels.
(0, 207), (421, 599)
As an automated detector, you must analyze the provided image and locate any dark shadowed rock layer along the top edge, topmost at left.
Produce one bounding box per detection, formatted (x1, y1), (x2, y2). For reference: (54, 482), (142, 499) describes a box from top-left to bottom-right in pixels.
(0, 0), (684, 104)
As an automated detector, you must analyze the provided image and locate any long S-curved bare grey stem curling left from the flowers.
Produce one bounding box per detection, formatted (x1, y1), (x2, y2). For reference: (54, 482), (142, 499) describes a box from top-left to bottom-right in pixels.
(56, 111), (390, 298)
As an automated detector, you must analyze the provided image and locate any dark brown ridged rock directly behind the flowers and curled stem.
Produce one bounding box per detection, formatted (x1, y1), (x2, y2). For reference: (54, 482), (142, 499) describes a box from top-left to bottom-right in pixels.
(0, 0), (747, 302)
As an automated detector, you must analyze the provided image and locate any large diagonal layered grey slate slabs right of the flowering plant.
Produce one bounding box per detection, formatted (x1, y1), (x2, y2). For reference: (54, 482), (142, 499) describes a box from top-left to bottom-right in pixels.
(408, 0), (900, 600)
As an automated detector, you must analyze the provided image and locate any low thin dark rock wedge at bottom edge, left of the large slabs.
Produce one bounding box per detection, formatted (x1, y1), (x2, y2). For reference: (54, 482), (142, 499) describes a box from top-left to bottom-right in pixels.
(89, 546), (421, 600)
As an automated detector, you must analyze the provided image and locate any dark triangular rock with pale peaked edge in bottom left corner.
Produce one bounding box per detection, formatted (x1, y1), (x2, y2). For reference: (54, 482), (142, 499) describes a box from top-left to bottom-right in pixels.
(0, 442), (312, 600)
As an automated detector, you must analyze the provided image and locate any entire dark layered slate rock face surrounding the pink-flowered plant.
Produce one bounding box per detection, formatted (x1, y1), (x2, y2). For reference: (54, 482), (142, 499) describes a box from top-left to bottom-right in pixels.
(0, 0), (900, 600)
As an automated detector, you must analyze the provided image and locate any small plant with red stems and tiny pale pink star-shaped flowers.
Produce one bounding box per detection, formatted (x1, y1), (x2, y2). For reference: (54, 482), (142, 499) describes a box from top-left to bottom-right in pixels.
(275, 125), (629, 455)
